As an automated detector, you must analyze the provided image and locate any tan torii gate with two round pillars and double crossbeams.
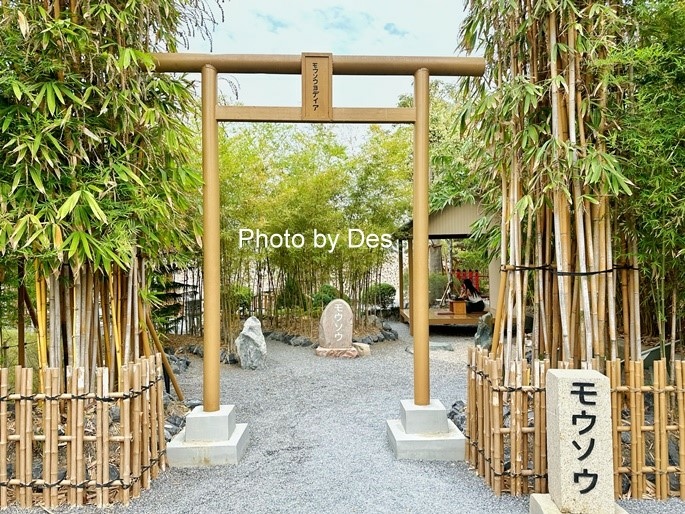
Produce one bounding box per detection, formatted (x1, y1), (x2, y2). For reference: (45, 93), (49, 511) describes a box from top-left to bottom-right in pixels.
(153, 53), (485, 464)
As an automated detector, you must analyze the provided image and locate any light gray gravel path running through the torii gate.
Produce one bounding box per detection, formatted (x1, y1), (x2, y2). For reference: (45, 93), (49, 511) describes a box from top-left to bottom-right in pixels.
(6, 324), (685, 514)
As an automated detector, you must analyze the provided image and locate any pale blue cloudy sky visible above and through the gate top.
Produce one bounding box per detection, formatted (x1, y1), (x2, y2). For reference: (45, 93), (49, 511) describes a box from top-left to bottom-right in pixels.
(188, 0), (464, 107)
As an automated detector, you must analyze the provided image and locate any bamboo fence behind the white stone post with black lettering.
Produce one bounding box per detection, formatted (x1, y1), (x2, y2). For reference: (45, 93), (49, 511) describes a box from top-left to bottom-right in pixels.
(464, 348), (685, 500)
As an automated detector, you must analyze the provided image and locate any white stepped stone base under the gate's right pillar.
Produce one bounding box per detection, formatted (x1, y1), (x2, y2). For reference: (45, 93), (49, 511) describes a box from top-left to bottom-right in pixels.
(387, 400), (466, 461)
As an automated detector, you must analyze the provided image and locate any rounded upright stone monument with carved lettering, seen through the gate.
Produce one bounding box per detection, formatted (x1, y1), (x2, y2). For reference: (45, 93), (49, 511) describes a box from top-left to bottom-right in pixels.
(316, 299), (358, 359)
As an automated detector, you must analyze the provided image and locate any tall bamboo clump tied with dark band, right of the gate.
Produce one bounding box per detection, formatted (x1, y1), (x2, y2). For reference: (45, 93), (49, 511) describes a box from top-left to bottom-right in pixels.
(460, 0), (676, 371)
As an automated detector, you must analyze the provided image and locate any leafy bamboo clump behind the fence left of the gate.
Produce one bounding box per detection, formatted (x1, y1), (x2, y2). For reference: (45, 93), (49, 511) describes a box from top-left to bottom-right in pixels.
(0, 0), (212, 385)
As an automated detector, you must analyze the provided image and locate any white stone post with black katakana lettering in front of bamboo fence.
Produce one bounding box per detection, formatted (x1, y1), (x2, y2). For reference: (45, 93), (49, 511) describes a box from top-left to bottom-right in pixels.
(530, 369), (625, 514)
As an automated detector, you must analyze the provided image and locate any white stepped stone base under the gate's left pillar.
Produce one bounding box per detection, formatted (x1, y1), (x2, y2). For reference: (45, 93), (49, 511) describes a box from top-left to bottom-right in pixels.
(167, 405), (250, 468)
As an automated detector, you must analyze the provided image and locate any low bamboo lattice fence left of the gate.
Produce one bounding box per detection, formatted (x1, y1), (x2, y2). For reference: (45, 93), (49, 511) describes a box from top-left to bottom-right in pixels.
(0, 354), (166, 509)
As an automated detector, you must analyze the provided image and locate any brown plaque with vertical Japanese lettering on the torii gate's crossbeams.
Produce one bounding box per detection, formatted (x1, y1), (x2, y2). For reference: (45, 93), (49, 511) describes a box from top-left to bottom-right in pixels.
(302, 53), (333, 121)
